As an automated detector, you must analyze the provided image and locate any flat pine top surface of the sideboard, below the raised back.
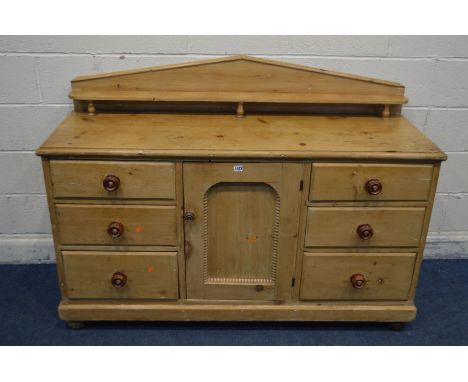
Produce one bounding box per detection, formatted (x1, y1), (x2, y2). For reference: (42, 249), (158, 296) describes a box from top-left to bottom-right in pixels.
(37, 112), (446, 161)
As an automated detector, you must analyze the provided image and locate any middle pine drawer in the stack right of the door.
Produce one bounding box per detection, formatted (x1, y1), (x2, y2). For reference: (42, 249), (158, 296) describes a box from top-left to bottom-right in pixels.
(305, 207), (425, 247)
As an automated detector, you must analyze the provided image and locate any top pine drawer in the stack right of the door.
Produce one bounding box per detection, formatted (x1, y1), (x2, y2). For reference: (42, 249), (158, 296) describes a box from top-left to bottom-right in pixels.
(309, 163), (432, 201)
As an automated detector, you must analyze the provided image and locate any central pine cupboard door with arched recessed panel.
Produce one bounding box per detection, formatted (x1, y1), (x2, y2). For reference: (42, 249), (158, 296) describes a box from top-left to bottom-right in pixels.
(183, 163), (303, 300)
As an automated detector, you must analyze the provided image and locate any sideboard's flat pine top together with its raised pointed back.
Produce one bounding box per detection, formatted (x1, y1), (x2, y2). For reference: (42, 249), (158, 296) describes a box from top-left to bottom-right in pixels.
(37, 56), (446, 161)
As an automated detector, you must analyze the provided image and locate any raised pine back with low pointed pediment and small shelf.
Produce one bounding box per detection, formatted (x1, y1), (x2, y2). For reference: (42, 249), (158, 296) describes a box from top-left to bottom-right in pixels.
(70, 56), (407, 116)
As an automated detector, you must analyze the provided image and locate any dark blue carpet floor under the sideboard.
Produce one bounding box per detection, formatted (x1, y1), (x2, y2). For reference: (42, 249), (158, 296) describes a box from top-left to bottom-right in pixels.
(0, 260), (468, 345)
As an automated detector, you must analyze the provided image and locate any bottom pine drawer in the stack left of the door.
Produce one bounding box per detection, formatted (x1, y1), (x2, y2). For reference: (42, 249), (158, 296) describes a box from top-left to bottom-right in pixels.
(62, 251), (178, 299)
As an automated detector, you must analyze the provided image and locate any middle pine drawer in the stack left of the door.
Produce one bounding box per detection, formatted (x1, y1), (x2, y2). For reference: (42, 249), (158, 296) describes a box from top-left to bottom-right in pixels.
(56, 204), (176, 245)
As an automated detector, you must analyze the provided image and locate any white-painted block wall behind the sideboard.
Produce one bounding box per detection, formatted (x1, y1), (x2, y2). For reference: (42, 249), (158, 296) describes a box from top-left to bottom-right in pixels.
(0, 36), (468, 263)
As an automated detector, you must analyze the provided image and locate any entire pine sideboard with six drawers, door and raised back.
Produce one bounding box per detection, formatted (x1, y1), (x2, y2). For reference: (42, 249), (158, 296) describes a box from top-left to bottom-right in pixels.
(37, 56), (446, 327)
